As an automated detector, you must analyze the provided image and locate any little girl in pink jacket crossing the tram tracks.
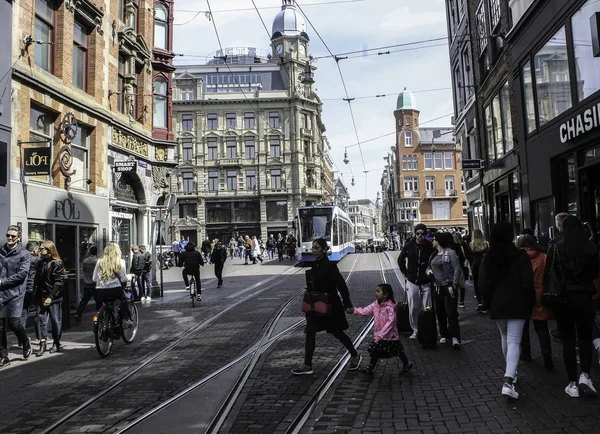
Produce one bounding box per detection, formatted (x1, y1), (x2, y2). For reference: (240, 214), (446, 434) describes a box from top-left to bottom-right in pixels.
(346, 283), (414, 377)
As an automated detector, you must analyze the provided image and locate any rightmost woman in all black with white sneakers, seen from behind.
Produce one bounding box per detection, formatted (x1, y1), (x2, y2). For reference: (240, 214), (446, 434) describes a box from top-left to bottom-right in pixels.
(544, 216), (598, 398)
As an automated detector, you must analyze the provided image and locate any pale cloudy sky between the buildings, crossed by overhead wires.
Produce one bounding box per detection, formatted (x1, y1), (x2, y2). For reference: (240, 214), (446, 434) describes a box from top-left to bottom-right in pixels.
(174, 0), (453, 201)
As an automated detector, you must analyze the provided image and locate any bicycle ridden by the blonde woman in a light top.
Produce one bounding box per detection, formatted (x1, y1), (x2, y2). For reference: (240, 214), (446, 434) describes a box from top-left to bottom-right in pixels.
(94, 297), (139, 358)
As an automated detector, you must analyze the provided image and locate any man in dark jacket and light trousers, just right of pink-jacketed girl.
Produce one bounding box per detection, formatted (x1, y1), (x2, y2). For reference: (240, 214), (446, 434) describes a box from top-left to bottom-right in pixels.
(398, 223), (433, 339)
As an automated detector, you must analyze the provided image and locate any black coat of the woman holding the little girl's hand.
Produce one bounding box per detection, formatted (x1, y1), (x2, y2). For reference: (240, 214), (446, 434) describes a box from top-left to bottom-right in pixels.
(306, 256), (352, 333)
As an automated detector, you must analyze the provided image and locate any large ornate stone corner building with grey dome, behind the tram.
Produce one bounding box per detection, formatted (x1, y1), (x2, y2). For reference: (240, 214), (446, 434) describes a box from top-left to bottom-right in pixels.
(169, 0), (332, 242)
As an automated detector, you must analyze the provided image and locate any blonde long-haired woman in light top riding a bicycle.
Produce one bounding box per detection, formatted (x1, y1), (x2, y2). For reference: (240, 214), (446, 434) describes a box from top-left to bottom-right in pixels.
(92, 241), (133, 328)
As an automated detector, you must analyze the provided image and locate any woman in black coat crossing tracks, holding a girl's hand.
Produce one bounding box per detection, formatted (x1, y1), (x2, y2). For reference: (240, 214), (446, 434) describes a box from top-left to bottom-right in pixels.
(292, 238), (362, 375)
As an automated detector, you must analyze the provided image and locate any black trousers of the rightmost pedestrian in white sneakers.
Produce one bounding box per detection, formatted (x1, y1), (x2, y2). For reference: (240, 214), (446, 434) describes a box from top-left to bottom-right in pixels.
(554, 293), (596, 381)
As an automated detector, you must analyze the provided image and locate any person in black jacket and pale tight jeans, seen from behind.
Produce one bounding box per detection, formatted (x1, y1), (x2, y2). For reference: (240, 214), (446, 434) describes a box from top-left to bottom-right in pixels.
(479, 222), (535, 399)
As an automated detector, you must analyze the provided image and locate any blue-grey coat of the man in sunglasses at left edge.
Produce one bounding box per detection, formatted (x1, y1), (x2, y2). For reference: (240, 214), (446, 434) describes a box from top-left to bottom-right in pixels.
(0, 244), (31, 318)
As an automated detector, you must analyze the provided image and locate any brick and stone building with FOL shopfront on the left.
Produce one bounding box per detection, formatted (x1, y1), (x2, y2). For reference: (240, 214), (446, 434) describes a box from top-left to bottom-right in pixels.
(10, 0), (174, 303)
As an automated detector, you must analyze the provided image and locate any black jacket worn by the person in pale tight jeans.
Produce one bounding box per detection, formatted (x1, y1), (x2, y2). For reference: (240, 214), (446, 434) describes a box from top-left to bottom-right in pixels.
(478, 247), (535, 319)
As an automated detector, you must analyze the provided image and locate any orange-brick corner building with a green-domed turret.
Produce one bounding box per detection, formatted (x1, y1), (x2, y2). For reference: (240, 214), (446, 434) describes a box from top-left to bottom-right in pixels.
(386, 89), (468, 236)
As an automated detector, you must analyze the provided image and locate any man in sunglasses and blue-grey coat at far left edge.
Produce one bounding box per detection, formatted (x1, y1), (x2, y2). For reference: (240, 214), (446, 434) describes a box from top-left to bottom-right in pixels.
(0, 225), (31, 368)
